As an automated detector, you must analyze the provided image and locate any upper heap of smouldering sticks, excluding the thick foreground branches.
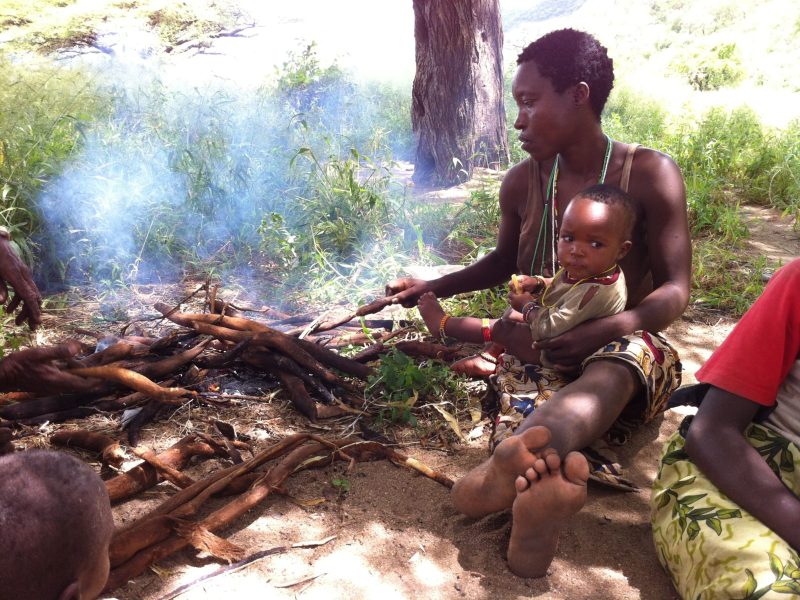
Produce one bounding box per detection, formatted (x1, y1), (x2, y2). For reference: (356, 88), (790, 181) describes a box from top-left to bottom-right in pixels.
(0, 298), (466, 446)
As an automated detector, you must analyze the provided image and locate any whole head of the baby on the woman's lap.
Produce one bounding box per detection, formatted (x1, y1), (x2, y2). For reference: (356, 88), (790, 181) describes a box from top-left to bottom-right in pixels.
(558, 184), (636, 279)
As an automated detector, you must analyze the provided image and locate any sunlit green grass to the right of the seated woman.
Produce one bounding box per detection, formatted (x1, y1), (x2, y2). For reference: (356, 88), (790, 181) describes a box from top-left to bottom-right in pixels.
(604, 90), (800, 315)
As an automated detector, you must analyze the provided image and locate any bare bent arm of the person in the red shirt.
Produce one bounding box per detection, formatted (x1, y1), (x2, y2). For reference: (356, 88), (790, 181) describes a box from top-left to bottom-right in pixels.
(686, 386), (800, 551)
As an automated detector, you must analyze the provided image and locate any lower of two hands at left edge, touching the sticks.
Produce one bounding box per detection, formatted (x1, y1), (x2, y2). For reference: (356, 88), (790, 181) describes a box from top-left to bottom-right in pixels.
(0, 340), (96, 393)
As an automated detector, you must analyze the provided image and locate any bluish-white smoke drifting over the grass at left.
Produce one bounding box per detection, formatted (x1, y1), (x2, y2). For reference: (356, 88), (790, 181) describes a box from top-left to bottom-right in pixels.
(31, 36), (412, 290)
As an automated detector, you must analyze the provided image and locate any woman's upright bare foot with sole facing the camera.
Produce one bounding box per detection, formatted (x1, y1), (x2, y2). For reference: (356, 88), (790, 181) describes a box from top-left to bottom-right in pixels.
(510, 446), (589, 577)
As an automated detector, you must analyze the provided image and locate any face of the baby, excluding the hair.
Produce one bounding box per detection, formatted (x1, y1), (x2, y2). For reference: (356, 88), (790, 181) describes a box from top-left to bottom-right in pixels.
(558, 196), (631, 279)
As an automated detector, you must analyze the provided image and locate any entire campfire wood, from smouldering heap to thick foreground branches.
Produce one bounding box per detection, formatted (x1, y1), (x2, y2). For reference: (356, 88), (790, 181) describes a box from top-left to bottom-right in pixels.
(0, 284), (460, 590)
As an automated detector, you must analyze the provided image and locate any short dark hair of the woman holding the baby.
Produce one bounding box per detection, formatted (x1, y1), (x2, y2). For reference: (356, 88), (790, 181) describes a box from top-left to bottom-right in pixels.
(517, 29), (614, 119)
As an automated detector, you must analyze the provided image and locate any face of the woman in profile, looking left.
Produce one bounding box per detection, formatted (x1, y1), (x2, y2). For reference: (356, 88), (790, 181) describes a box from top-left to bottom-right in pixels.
(511, 61), (577, 161)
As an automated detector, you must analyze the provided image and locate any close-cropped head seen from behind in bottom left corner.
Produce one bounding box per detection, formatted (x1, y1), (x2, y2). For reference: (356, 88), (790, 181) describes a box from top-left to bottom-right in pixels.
(0, 450), (114, 600)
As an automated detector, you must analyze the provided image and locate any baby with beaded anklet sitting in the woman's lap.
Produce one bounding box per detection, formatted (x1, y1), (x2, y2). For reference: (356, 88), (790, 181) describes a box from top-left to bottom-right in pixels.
(419, 184), (636, 366)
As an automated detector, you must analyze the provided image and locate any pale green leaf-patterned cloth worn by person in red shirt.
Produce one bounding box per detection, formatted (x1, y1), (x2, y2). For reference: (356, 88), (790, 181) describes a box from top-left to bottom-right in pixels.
(650, 417), (800, 600)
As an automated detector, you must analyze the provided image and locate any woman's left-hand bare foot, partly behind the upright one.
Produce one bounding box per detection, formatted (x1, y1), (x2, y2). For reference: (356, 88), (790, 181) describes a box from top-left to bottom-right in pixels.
(452, 426), (552, 517)
